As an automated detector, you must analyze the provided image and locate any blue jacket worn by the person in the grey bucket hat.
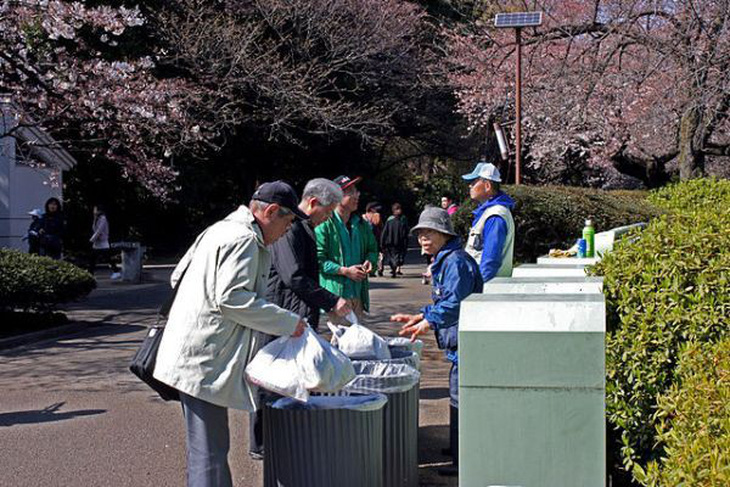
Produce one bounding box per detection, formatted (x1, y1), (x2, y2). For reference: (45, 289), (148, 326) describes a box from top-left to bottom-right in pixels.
(421, 238), (483, 363)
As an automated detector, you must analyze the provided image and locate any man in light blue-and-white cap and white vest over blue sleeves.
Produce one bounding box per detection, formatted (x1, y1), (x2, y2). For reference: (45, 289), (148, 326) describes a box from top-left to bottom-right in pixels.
(462, 162), (515, 282)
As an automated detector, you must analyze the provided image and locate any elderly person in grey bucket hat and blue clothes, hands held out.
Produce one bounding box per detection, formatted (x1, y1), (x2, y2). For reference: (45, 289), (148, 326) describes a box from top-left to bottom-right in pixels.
(390, 207), (483, 475)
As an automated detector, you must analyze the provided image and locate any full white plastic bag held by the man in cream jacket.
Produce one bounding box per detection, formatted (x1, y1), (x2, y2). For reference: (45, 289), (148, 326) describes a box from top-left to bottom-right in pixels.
(246, 327), (355, 401)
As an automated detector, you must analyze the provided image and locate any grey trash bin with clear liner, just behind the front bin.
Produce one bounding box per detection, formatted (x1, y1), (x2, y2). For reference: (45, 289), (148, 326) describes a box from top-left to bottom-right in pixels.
(343, 360), (421, 487)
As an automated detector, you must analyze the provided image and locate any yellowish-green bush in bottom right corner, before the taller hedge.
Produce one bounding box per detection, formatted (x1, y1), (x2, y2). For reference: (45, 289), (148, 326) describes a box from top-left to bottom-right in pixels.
(637, 339), (730, 487)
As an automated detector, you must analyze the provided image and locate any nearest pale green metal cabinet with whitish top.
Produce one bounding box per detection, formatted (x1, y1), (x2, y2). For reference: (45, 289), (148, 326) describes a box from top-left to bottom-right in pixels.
(459, 292), (606, 487)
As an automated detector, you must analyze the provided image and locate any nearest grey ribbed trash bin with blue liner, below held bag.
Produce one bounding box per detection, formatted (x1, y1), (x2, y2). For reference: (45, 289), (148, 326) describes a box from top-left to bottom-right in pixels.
(264, 394), (387, 487)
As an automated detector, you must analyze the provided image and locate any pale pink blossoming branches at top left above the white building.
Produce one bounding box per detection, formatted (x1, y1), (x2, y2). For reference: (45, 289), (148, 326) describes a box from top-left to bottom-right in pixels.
(0, 0), (211, 197)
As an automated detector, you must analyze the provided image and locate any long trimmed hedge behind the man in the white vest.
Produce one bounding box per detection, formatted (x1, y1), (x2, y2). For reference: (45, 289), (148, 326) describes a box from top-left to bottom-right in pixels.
(454, 185), (662, 262)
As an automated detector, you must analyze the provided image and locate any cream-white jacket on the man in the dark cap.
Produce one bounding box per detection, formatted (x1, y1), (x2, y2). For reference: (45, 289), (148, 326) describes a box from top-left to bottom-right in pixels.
(154, 206), (299, 411)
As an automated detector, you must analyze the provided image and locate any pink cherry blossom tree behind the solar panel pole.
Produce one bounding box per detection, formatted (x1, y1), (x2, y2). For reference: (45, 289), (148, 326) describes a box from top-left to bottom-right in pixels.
(440, 0), (730, 186)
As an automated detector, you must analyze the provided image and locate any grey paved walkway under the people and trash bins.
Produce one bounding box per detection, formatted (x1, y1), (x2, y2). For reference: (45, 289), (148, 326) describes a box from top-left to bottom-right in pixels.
(0, 252), (457, 487)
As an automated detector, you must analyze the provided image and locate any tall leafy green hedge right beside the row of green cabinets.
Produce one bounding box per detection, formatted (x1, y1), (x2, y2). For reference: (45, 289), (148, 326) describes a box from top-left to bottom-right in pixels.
(592, 180), (730, 479)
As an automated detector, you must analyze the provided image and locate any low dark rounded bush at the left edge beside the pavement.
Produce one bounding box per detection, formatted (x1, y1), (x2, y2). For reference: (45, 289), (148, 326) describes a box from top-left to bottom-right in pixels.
(0, 249), (96, 311)
